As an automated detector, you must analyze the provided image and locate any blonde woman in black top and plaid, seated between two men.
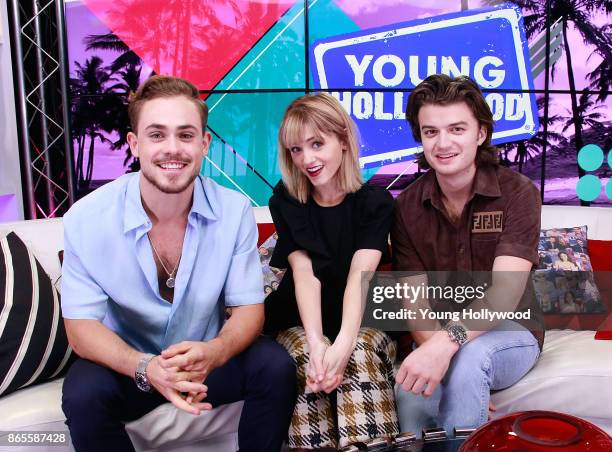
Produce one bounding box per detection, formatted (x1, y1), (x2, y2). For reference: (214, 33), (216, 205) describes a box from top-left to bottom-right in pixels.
(265, 94), (398, 448)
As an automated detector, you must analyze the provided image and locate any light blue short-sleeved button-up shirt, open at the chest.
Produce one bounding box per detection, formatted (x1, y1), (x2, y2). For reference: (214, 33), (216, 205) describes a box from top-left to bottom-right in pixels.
(61, 173), (264, 354)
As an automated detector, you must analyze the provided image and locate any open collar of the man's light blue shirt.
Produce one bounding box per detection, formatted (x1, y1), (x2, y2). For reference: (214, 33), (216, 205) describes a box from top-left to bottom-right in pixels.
(123, 175), (218, 233)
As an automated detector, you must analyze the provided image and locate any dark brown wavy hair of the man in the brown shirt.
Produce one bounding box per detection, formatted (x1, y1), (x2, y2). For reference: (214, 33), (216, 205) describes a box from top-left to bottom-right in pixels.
(406, 74), (499, 169)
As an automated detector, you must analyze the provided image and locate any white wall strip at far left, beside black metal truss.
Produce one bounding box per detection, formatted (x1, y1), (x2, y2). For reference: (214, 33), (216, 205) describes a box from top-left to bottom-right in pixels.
(0, 1), (23, 220)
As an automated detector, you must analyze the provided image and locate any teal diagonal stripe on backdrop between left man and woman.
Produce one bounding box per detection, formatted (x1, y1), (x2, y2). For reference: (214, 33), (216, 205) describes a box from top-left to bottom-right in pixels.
(202, 1), (377, 206)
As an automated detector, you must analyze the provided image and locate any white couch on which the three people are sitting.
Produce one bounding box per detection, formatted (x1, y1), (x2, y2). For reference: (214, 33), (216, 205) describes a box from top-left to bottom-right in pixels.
(0, 206), (612, 452)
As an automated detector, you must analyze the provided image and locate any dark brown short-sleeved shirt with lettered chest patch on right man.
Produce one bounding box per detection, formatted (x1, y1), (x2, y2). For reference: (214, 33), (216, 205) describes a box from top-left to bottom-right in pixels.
(391, 166), (544, 348)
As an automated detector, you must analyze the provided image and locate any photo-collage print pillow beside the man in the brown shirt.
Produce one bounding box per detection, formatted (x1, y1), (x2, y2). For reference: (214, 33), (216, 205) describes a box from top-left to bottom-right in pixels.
(533, 226), (605, 314)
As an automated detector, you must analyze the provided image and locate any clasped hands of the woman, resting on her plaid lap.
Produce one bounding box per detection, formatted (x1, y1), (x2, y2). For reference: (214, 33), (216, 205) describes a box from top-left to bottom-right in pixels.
(306, 335), (356, 394)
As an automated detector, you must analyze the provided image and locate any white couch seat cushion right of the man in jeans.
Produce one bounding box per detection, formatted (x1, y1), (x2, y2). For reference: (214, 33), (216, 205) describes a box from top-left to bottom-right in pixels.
(492, 330), (612, 433)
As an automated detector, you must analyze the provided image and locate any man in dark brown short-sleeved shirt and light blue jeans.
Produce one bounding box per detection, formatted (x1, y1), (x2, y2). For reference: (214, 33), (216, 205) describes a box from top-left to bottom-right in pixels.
(391, 75), (543, 433)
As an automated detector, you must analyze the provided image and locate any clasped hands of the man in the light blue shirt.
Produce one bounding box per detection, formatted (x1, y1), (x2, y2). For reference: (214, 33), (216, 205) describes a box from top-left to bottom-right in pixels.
(146, 340), (221, 415)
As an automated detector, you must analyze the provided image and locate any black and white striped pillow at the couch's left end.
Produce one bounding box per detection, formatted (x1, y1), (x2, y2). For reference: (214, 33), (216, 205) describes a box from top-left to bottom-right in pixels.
(0, 232), (72, 396)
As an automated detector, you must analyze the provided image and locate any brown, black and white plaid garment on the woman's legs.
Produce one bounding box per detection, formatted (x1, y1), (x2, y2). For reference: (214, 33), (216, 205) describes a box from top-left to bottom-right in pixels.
(276, 327), (399, 448)
